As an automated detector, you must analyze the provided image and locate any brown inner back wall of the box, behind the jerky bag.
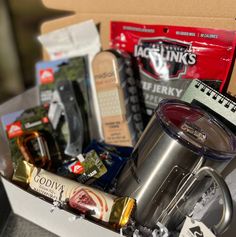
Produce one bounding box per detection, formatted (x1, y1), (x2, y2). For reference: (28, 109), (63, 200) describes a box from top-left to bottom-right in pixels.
(41, 13), (236, 49)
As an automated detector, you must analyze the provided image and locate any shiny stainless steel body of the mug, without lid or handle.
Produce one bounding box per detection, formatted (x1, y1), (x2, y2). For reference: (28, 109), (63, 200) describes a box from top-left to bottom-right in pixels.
(117, 116), (200, 226)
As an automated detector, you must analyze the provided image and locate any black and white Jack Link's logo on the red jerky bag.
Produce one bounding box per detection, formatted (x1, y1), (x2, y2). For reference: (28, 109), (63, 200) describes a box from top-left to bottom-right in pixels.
(134, 37), (197, 80)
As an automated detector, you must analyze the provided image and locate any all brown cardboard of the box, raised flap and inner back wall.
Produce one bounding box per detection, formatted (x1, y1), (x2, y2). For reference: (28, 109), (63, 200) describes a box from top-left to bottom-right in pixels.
(41, 0), (236, 96)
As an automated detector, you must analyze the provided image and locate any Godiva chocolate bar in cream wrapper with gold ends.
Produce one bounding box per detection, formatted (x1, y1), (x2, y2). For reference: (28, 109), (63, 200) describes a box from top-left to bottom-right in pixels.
(13, 161), (135, 227)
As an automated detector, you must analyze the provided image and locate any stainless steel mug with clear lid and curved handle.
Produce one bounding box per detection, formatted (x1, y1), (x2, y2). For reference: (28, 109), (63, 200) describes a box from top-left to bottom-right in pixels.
(117, 100), (236, 232)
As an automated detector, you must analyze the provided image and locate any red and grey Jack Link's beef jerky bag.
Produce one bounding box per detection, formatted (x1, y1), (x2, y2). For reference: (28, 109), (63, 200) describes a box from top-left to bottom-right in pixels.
(111, 22), (235, 122)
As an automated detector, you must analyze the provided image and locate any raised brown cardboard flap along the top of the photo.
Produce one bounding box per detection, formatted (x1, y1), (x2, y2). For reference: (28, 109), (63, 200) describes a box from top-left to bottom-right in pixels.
(43, 0), (236, 20)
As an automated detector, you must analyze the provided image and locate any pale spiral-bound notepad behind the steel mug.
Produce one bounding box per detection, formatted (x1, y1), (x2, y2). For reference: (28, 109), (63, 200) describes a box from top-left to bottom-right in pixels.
(181, 79), (236, 133)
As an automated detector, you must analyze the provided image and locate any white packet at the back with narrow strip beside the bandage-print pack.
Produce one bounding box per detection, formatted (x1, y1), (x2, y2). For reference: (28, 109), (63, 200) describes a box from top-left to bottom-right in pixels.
(38, 20), (103, 139)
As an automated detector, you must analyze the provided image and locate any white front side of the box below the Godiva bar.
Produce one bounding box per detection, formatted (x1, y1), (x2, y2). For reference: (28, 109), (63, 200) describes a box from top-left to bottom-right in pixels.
(2, 178), (120, 237)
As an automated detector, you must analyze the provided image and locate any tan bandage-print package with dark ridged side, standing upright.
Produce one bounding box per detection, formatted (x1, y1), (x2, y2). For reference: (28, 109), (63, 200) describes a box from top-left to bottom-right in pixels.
(92, 50), (143, 146)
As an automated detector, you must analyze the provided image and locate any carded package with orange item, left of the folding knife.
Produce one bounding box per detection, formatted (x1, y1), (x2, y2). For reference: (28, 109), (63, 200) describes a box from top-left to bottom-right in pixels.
(1, 106), (61, 170)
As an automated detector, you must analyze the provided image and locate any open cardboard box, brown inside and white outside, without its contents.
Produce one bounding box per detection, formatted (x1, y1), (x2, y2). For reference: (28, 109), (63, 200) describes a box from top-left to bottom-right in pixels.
(0, 0), (236, 237)
